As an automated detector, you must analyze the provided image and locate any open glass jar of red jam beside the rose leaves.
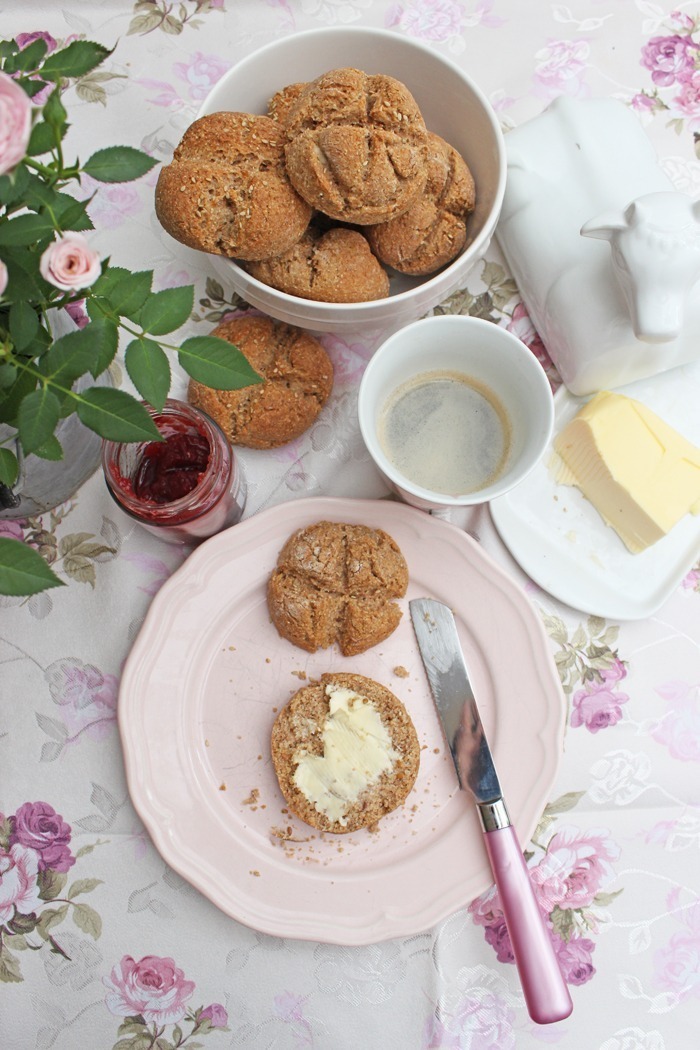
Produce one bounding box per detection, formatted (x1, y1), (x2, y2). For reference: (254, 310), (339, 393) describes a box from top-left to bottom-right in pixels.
(102, 399), (246, 544)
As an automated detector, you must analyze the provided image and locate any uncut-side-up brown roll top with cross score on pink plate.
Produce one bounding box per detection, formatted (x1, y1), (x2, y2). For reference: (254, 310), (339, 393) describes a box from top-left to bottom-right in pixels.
(268, 521), (408, 656)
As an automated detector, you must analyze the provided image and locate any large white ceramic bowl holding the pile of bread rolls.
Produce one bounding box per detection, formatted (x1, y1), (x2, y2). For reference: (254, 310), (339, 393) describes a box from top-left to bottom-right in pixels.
(199, 26), (506, 332)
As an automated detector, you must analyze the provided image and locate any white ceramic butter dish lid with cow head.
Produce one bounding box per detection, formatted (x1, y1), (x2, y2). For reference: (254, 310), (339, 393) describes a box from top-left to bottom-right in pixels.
(496, 98), (700, 395)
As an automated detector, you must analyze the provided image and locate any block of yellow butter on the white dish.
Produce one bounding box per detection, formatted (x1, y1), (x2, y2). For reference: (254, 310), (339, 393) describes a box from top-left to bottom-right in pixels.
(554, 391), (700, 553)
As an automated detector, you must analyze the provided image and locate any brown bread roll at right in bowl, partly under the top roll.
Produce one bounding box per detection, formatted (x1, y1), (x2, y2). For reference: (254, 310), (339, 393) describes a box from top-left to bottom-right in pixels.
(366, 132), (475, 276)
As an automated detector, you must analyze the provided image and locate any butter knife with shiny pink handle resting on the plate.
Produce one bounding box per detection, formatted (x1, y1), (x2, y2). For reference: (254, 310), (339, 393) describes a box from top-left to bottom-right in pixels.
(408, 597), (573, 1025)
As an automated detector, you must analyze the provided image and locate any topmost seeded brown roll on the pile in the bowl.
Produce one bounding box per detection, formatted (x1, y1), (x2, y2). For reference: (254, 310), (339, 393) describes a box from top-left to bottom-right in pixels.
(285, 68), (427, 224)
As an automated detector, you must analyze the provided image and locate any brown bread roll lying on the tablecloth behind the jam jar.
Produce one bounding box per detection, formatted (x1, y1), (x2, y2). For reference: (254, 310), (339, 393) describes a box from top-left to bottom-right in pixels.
(188, 316), (333, 448)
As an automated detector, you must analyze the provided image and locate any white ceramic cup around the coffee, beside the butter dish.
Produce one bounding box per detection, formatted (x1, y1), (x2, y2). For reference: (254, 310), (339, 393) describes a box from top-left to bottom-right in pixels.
(358, 314), (554, 510)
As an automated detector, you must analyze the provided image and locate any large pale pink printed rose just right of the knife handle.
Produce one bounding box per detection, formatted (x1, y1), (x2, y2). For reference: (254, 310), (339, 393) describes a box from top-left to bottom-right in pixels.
(530, 826), (619, 914)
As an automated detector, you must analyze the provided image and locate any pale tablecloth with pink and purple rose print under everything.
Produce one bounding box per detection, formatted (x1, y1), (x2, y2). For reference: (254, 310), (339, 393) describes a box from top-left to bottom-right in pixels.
(0, 0), (700, 1050)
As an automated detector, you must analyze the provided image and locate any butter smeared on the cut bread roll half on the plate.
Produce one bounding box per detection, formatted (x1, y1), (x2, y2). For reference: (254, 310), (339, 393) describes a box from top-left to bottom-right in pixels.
(294, 685), (399, 825)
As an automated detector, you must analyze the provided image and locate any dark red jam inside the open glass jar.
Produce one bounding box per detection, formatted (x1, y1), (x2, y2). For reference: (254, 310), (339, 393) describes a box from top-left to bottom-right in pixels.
(133, 432), (211, 503)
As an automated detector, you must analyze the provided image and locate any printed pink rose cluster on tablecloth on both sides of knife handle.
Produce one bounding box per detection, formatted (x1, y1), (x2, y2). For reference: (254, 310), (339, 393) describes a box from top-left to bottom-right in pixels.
(468, 803), (619, 985)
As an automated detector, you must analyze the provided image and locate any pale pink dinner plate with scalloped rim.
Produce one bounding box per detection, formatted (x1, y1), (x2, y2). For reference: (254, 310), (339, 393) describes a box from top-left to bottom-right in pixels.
(119, 499), (566, 945)
